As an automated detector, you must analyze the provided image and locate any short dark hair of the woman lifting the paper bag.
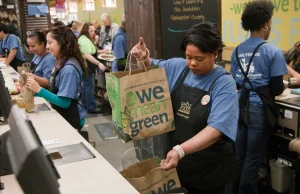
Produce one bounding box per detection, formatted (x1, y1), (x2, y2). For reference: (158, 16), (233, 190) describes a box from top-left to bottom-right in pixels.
(181, 22), (225, 53)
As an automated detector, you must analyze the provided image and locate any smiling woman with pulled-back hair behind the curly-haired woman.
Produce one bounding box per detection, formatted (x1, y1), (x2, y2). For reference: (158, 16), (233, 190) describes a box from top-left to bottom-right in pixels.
(27, 31), (56, 88)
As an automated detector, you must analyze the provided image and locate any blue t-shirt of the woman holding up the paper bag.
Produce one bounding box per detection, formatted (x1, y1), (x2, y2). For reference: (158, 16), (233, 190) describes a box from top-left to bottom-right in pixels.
(152, 58), (239, 141)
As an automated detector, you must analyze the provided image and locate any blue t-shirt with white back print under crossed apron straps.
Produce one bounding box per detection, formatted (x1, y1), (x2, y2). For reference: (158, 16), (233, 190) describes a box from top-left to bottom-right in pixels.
(230, 38), (288, 105)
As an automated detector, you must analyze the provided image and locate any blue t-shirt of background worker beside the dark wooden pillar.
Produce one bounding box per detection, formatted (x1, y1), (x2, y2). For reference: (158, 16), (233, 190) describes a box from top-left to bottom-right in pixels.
(112, 28), (127, 72)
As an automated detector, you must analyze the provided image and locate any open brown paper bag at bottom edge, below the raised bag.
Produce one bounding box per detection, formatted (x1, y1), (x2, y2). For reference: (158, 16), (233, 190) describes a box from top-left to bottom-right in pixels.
(120, 157), (181, 194)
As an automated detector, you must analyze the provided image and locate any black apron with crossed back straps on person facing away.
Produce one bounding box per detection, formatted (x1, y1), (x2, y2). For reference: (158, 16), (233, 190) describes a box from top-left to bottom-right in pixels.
(235, 42), (279, 127)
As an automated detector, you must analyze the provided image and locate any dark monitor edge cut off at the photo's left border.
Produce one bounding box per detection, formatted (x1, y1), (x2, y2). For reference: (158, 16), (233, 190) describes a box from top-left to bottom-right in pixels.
(0, 70), (12, 123)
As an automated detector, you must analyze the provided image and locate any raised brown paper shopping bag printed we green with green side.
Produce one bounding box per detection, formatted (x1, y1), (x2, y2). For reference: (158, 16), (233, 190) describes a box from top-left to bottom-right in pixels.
(105, 52), (175, 142)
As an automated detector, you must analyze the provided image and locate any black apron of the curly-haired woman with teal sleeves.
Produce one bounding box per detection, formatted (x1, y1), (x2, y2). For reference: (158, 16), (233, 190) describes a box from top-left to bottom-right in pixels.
(49, 64), (81, 130)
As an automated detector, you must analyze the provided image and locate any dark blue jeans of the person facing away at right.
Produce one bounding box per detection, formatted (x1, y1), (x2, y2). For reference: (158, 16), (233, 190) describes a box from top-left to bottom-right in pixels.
(230, 104), (269, 194)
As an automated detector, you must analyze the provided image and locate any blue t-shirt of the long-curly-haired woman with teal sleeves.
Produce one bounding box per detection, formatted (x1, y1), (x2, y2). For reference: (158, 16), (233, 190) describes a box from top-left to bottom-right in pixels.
(55, 59), (86, 119)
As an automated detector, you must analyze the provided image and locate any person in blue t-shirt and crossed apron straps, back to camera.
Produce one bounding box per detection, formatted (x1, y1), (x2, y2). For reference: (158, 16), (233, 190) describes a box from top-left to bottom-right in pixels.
(230, 1), (288, 194)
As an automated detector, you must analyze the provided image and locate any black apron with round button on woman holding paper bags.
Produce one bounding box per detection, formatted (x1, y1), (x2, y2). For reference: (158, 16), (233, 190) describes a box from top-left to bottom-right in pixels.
(170, 68), (237, 190)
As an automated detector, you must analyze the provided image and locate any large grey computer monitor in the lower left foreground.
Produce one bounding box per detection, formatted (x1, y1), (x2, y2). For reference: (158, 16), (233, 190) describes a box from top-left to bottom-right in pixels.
(7, 105), (60, 194)
